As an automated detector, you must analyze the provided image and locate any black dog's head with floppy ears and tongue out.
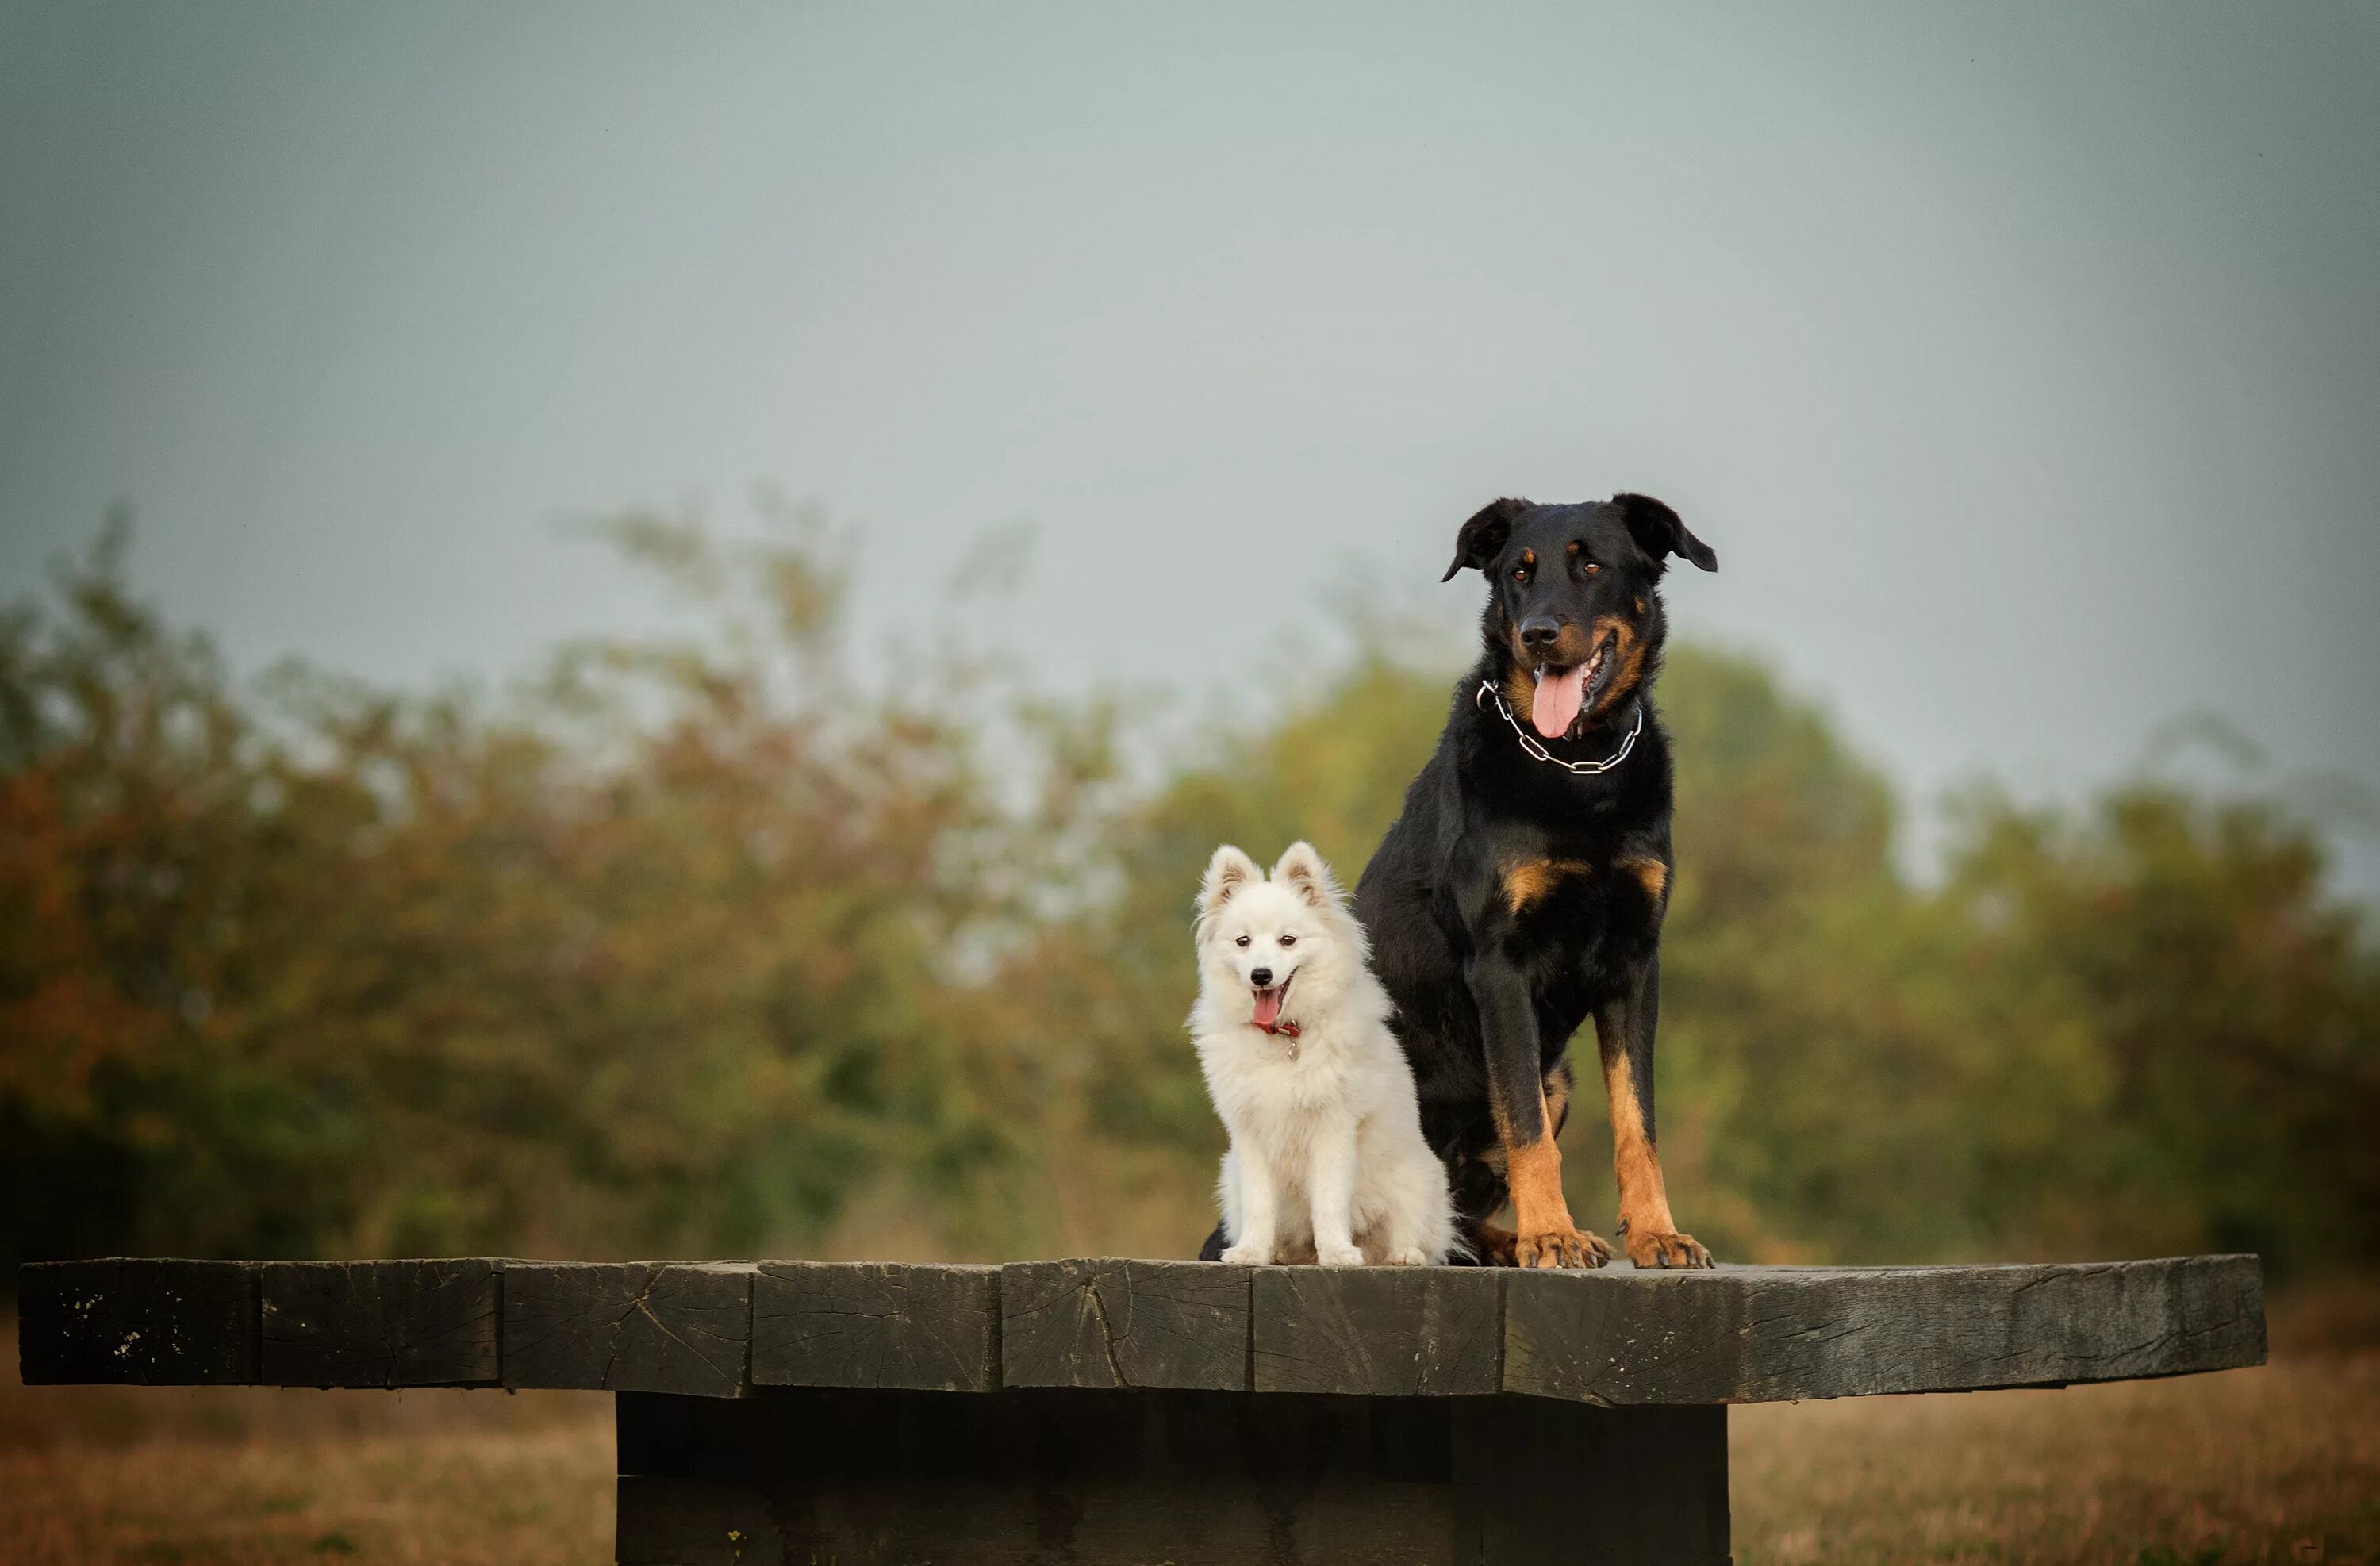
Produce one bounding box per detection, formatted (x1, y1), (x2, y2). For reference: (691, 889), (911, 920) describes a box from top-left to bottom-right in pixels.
(1442, 495), (1718, 740)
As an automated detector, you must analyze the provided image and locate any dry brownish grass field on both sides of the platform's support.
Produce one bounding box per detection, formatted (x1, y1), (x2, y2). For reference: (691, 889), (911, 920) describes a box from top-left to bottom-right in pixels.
(0, 1295), (2380, 1566)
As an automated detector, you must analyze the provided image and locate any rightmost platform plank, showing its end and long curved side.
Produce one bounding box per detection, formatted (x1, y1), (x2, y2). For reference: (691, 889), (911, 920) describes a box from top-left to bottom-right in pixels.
(1504, 1257), (2263, 1404)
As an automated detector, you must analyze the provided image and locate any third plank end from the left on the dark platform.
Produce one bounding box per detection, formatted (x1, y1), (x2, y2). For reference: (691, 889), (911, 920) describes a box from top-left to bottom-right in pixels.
(502, 1261), (754, 1397)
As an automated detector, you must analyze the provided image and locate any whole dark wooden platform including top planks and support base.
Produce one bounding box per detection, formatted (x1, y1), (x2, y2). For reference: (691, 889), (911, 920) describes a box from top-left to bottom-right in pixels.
(17, 1257), (2263, 1566)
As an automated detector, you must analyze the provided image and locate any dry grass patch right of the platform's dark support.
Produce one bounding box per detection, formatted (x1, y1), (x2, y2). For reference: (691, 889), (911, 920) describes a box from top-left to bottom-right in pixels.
(1728, 1352), (2380, 1566)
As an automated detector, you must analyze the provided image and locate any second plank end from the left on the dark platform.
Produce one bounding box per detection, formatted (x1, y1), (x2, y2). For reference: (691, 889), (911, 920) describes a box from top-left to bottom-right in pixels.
(262, 1257), (500, 1388)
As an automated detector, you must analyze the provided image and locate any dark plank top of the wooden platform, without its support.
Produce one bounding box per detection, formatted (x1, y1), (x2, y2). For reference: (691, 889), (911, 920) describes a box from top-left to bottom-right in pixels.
(17, 1257), (2263, 1407)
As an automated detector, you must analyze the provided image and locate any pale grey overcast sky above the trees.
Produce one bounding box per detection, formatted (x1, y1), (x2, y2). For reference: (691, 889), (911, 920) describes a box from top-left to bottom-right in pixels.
(0, 0), (2380, 885)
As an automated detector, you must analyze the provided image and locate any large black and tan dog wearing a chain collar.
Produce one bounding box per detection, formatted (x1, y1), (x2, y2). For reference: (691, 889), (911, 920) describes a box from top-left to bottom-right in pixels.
(1354, 495), (1718, 1266)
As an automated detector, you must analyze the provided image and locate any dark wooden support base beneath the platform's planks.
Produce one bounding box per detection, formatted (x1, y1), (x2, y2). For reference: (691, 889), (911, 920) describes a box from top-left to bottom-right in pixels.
(619, 1388), (1728, 1566)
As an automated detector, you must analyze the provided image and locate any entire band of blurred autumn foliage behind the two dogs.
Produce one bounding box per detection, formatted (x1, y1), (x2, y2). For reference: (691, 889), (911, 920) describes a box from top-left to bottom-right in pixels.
(0, 514), (2380, 1269)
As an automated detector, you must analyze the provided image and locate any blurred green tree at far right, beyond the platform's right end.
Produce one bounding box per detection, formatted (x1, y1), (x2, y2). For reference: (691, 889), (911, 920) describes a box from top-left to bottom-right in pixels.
(1949, 783), (2380, 1271)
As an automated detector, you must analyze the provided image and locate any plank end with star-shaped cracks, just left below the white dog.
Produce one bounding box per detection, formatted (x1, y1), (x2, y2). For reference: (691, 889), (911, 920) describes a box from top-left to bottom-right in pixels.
(1000, 1257), (1259, 1392)
